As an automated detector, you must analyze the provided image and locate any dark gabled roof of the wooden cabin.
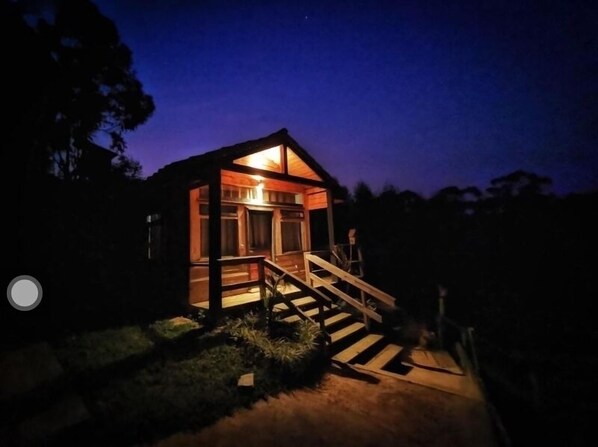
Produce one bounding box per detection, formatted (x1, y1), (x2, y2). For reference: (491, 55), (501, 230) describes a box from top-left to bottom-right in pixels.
(148, 129), (338, 188)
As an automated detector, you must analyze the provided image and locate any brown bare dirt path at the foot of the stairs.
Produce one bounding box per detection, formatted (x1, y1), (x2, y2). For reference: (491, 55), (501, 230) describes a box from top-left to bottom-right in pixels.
(157, 373), (498, 447)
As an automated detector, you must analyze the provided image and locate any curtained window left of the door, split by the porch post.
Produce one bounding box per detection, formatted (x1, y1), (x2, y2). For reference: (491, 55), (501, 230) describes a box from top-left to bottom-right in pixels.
(199, 204), (239, 258)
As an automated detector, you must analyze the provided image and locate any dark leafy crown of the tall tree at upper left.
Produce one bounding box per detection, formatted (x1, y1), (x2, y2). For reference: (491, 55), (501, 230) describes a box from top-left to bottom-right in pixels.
(5, 0), (154, 180)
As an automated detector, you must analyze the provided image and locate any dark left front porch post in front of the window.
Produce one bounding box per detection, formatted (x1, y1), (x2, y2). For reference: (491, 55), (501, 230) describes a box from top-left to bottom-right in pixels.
(208, 168), (222, 318)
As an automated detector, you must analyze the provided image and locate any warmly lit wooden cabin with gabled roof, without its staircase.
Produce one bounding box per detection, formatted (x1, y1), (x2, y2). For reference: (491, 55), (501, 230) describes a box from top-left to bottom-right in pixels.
(147, 129), (338, 311)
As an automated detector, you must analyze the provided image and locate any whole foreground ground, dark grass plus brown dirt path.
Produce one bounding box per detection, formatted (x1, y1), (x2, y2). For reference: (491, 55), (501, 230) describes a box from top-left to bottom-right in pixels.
(0, 321), (500, 447)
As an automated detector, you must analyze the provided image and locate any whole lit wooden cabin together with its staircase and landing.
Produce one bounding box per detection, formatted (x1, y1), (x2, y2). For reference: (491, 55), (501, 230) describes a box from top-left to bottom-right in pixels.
(147, 129), (481, 399)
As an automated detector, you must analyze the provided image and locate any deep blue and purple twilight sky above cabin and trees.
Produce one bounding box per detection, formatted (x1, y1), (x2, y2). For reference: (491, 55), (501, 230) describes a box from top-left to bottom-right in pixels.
(97, 0), (598, 195)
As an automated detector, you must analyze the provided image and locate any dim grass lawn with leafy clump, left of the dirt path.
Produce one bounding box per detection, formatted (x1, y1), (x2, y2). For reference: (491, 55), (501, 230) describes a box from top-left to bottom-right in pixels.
(50, 317), (323, 444)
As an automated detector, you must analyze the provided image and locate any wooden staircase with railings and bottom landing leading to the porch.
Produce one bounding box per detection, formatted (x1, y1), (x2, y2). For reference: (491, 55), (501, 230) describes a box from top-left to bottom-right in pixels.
(202, 252), (483, 399)
